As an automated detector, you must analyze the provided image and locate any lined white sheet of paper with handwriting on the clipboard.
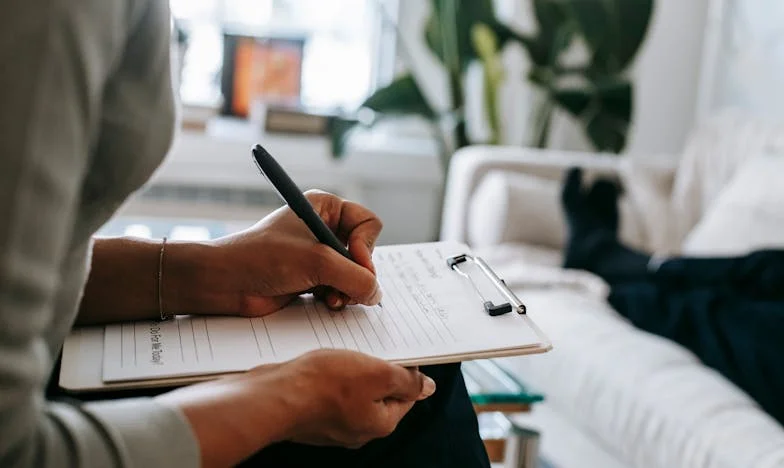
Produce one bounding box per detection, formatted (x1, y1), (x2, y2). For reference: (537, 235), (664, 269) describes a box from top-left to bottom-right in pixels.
(103, 243), (539, 382)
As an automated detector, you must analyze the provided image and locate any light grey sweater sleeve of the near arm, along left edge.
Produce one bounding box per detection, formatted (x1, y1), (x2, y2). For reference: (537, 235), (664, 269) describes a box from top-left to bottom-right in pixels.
(0, 0), (199, 467)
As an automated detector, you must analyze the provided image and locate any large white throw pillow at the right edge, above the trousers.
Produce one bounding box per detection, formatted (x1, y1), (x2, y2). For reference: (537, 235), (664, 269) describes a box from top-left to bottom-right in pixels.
(682, 153), (784, 256)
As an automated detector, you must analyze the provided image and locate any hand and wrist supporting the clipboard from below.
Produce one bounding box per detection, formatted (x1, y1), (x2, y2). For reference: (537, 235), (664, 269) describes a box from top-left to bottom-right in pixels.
(158, 350), (435, 466)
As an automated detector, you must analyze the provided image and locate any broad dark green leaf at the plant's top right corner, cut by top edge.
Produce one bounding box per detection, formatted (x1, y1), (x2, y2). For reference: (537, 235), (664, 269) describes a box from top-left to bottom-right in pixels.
(564, 0), (653, 75)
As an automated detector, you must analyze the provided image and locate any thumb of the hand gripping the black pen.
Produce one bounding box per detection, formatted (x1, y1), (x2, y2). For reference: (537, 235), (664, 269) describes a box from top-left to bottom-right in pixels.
(314, 245), (381, 305)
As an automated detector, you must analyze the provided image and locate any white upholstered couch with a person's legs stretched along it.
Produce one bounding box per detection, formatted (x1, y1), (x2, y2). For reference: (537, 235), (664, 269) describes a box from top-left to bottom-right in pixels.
(441, 112), (784, 468)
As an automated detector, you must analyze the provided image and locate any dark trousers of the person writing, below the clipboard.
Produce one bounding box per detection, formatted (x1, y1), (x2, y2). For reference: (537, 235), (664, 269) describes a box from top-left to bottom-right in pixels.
(49, 364), (490, 468)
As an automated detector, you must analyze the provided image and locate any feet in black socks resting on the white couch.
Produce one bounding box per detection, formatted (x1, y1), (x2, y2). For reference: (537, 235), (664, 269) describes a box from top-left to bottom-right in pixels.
(561, 168), (650, 280)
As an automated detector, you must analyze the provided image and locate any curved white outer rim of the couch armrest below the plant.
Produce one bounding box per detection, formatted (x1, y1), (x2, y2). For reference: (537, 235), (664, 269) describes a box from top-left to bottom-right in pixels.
(441, 145), (621, 242)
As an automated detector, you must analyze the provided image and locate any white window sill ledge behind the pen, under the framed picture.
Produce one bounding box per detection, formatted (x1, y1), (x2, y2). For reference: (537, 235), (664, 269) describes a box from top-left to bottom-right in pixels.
(152, 118), (442, 190)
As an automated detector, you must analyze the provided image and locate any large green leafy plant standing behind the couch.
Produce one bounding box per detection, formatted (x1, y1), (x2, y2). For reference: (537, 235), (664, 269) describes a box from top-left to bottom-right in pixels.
(331, 0), (653, 170)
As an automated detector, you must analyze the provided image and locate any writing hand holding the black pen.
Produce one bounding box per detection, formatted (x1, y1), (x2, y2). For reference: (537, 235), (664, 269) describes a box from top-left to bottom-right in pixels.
(172, 191), (382, 316)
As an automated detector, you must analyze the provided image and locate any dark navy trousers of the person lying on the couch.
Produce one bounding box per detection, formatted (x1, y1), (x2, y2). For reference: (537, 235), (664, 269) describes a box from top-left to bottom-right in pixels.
(609, 250), (784, 424)
